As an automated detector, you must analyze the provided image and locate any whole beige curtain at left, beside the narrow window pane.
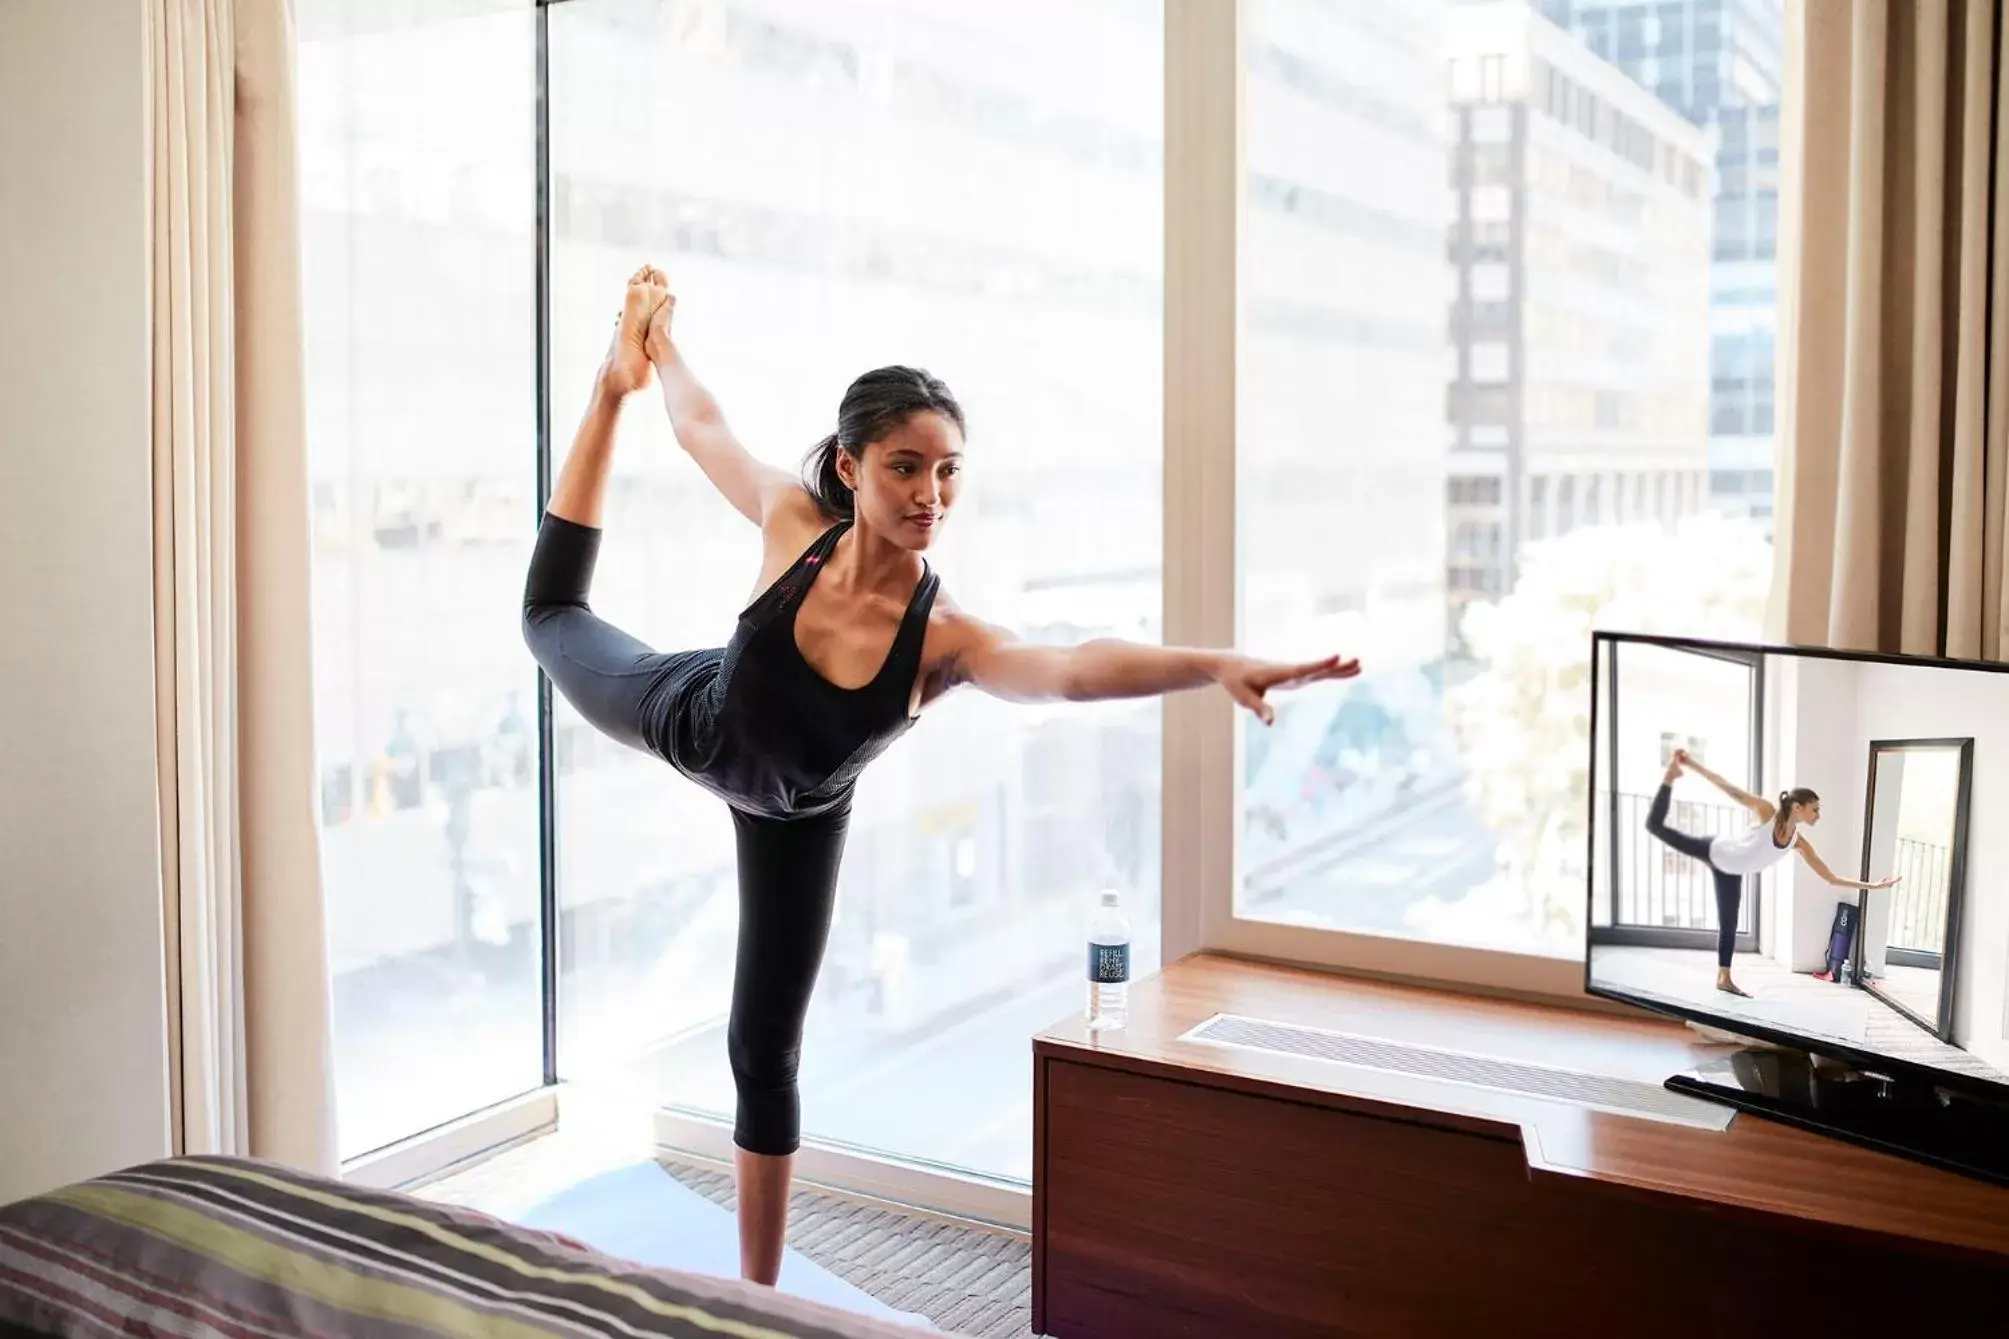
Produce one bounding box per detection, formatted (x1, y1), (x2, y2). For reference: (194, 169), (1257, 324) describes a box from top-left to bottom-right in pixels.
(149, 0), (336, 1170)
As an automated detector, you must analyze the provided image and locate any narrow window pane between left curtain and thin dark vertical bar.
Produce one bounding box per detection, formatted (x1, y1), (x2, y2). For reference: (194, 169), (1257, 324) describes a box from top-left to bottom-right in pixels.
(297, 0), (542, 1156)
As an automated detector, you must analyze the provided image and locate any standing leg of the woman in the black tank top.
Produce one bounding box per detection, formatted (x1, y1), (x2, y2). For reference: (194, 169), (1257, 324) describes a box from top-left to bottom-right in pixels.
(725, 805), (850, 1287)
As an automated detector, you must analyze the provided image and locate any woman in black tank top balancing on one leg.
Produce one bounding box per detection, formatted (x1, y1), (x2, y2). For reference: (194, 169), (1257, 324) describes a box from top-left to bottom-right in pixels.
(522, 267), (1360, 1285)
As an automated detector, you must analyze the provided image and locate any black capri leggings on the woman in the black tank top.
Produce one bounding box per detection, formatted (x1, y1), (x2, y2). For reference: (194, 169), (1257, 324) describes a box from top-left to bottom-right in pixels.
(522, 518), (850, 1156)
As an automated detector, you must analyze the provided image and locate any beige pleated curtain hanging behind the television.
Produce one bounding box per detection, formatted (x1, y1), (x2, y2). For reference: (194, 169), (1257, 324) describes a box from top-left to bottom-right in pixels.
(1770, 0), (2009, 658)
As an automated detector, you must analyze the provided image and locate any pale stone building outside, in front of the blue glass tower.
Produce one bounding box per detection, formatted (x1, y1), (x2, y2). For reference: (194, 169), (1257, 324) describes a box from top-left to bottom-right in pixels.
(1446, 4), (1710, 650)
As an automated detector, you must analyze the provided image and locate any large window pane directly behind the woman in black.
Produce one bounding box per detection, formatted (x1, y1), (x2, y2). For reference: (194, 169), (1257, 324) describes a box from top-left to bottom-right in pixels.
(550, 0), (1165, 1180)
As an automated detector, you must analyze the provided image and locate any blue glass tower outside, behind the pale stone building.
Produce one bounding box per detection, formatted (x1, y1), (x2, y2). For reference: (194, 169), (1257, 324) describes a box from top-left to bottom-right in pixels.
(1541, 0), (1784, 530)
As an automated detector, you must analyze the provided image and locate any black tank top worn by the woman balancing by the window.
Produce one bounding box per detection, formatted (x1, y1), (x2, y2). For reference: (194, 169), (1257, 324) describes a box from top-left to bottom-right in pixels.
(661, 522), (938, 817)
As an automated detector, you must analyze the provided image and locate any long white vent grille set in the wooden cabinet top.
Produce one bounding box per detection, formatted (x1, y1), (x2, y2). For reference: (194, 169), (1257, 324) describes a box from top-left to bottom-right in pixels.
(1179, 1014), (1736, 1130)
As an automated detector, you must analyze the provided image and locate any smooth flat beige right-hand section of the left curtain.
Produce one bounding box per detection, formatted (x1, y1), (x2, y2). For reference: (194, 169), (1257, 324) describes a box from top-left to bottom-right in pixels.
(233, 0), (338, 1172)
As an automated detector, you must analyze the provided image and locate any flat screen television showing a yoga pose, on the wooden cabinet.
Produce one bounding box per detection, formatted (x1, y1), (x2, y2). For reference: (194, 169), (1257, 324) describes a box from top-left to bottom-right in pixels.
(1583, 632), (2009, 1184)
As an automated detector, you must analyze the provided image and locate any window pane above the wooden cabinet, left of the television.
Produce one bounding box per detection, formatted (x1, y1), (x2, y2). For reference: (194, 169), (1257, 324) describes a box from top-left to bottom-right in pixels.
(1238, 0), (1780, 956)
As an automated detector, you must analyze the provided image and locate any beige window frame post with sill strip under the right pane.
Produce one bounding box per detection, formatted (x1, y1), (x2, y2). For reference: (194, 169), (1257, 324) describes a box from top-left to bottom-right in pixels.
(1159, 0), (1587, 1002)
